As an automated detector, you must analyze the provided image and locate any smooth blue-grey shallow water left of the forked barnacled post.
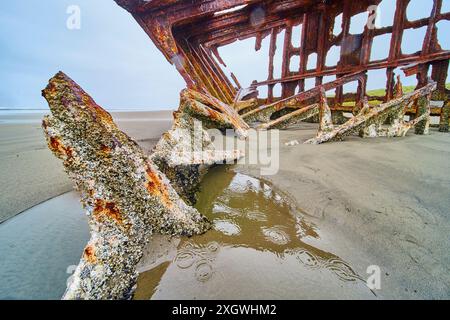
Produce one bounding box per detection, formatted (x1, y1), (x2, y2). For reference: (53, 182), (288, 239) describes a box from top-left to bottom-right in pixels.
(0, 191), (89, 300)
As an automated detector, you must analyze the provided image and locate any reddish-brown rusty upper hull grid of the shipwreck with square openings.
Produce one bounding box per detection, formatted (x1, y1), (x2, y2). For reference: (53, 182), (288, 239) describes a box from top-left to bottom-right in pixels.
(115, 0), (450, 131)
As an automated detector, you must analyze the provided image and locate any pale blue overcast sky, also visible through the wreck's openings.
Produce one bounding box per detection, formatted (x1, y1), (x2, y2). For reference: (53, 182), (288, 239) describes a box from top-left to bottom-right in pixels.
(0, 0), (450, 110)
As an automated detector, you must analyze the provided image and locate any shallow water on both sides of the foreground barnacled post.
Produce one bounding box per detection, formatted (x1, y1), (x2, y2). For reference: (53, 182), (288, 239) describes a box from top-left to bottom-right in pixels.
(0, 166), (373, 299)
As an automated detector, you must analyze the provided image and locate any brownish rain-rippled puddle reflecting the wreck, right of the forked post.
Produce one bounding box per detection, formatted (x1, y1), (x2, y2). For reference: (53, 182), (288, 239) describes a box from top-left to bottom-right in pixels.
(136, 167), (370, 299)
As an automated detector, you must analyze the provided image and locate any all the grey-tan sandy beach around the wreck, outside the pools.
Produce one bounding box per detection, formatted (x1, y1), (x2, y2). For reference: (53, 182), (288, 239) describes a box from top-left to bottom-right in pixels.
(0, 111), (450, 299)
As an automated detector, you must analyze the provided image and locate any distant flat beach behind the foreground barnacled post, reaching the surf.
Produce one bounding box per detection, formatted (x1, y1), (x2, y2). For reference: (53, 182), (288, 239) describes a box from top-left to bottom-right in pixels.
(0, 111), (172, 223)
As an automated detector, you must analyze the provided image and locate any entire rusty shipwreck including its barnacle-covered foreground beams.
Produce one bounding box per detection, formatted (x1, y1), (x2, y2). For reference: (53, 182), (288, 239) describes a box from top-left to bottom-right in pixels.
(38, 0), (450, 299)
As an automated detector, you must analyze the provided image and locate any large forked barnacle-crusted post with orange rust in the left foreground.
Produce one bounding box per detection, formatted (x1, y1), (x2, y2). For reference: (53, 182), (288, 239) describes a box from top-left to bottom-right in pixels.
(42, 73), (210, 299)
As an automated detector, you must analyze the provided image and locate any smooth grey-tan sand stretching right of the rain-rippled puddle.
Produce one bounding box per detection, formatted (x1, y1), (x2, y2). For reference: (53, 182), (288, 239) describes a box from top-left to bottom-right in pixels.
(237, 124), (450, 299)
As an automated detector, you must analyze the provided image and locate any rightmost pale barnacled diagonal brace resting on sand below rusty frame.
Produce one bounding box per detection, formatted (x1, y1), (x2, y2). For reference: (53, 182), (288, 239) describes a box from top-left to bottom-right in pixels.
(305, 81), (436, 144)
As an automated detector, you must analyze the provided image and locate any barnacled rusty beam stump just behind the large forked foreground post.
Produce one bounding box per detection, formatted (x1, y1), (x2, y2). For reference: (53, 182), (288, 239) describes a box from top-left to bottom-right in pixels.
(151, 89), (249, 204)
